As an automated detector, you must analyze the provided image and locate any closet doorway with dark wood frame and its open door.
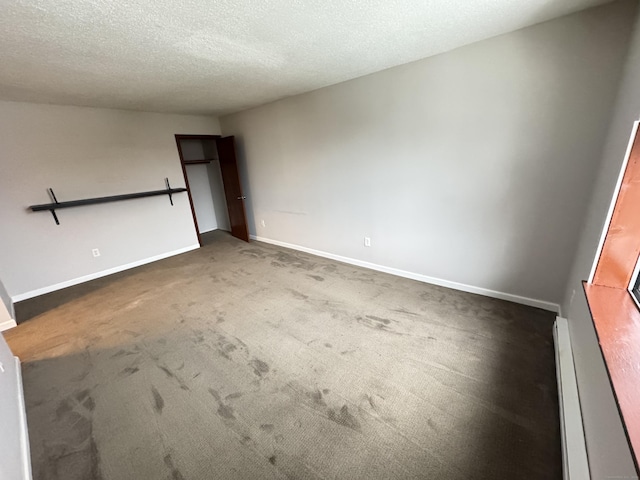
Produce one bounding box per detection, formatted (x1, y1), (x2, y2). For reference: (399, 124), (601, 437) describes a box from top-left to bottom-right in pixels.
(176, 135), (249, 245)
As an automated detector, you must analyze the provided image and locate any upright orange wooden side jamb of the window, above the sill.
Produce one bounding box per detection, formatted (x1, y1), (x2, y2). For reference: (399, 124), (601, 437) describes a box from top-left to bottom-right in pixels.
(593, 129), (640, 289)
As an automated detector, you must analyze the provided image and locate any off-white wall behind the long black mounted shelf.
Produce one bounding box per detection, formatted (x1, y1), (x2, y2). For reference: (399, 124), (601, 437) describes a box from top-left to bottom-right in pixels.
(0, 102), (219, 298)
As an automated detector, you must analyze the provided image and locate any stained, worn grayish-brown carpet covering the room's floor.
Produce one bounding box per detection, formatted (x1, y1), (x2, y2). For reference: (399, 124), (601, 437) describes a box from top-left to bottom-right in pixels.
(6, 232), (561, 480)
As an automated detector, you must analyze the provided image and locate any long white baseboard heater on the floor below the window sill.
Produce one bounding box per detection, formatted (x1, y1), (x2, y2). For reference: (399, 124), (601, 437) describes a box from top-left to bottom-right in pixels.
(553, 317), (591, 480)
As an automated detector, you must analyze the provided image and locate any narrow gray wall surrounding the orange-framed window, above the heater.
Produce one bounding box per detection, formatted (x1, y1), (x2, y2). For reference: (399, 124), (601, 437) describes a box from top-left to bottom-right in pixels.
(562, 1), (640, 479)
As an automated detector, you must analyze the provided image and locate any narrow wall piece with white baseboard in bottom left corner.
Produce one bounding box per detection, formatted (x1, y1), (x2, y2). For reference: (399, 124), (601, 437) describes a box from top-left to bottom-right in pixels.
(0, 334), (31, 480)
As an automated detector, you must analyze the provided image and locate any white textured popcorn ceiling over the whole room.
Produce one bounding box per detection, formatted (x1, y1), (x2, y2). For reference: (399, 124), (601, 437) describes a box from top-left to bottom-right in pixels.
(0, 0), (607, 114)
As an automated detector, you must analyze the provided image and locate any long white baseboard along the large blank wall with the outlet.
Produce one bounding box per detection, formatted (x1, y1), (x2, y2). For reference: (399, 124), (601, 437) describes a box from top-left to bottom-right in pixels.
(250, 235), (560, 313)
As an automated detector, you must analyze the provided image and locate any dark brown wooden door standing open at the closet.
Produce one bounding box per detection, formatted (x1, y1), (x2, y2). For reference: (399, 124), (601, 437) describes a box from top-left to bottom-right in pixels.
(216, 137), (249, 242)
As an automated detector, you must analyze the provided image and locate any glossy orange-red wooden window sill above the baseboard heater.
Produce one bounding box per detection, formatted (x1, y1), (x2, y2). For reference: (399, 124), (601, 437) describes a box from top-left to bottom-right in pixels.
(584, 282), (640, 469)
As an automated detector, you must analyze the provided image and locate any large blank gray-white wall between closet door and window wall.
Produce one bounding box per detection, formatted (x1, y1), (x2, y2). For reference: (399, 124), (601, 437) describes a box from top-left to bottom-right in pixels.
(221, 2), (634, 303)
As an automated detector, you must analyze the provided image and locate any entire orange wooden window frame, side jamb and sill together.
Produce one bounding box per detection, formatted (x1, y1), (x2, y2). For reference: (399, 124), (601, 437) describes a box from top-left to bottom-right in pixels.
(583, 121), (640, 472)
